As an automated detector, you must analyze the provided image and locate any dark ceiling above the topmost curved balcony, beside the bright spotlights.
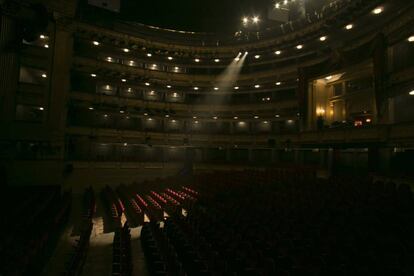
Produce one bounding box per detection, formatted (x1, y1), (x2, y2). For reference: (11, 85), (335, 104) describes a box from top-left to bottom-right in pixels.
(88, 0), (274, 32)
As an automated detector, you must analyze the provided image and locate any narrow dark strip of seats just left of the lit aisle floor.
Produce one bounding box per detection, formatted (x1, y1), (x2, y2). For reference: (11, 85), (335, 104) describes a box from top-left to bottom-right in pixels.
(64, 187), (96, 276)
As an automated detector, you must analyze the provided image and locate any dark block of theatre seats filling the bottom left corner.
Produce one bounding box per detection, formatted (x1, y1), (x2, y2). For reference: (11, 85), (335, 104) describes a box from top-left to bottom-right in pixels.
(0, 187), (71, 275)
